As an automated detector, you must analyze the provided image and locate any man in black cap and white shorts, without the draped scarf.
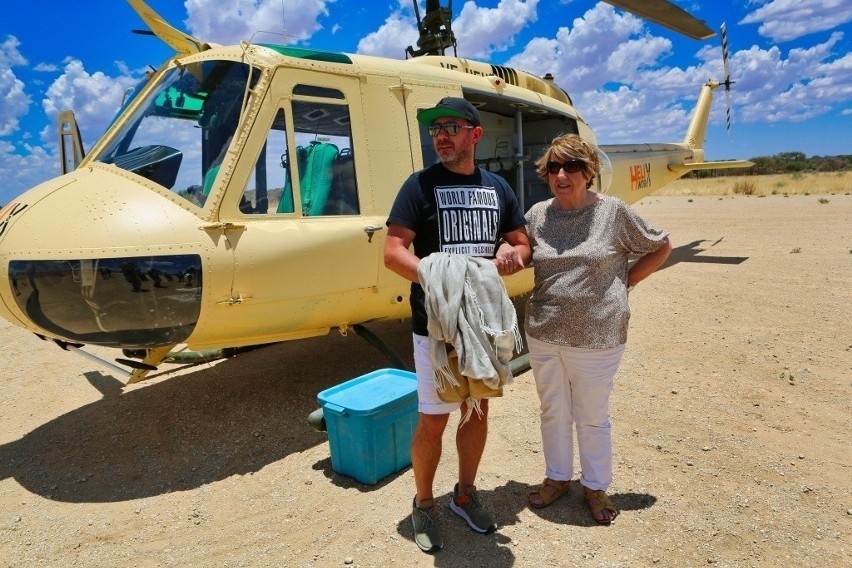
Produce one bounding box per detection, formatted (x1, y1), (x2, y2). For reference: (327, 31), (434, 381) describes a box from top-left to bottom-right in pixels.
(384, 97), (531, 552)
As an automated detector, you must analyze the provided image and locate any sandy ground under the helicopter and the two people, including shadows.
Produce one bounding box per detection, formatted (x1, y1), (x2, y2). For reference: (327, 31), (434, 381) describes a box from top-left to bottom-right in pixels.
(0, 195), (852, 567)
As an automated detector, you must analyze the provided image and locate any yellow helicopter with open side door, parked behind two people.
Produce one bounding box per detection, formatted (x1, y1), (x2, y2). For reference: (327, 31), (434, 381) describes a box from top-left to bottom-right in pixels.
(0, 0), (751, 383)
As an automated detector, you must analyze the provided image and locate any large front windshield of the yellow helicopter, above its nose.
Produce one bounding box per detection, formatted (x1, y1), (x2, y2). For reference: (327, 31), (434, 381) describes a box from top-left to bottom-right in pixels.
(95, 61), (259, 206)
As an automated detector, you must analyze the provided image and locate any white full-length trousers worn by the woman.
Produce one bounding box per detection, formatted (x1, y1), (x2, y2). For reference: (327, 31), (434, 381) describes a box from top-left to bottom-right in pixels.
(527, 336), (625, 490)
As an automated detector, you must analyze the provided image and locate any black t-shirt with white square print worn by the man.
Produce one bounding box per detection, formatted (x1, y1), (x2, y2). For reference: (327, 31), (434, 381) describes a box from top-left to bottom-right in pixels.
(387, 162), (526, 336)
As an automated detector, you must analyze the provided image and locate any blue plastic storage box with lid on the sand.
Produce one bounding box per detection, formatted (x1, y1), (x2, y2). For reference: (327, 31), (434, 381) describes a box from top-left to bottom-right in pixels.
(317, 369), (417, 485)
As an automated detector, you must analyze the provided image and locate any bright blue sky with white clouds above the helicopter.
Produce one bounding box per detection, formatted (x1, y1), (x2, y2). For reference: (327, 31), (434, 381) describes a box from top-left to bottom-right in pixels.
(0, 0), (852, 204)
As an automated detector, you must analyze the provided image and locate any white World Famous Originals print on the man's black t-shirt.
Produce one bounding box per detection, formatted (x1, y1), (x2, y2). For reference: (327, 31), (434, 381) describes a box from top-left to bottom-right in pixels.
(435, 186), (500, 257)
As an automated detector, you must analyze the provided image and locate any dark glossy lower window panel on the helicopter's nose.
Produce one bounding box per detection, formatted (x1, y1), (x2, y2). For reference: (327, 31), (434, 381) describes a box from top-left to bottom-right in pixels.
(8, 255), (201, 347)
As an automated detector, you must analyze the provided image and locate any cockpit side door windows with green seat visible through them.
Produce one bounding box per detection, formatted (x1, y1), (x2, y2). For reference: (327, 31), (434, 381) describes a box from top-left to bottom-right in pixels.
(240, 85), (360, 217)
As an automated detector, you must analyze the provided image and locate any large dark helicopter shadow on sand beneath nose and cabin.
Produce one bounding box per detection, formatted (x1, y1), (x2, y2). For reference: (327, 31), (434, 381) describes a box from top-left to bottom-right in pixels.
(0, 321), (413, 503)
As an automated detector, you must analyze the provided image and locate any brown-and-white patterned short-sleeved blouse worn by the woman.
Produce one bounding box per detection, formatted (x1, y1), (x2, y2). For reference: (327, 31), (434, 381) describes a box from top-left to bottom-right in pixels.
(525, 195), (668, 349)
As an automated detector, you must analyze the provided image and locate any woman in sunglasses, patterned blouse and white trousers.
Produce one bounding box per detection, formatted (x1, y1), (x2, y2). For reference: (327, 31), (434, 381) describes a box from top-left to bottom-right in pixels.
(525, 134), (671, 525)
